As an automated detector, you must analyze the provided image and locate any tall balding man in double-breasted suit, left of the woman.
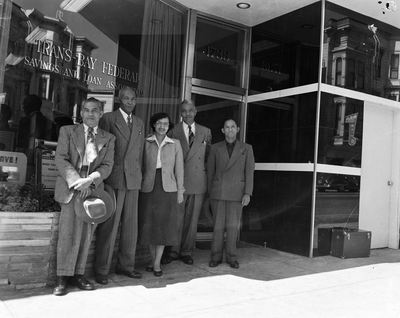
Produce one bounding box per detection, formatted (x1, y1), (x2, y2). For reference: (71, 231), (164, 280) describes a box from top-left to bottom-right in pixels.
(95, 86), (144, 285)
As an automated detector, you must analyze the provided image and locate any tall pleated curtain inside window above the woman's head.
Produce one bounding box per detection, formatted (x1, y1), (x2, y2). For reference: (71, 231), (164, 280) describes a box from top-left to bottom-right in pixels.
(135, 0), (183, 133)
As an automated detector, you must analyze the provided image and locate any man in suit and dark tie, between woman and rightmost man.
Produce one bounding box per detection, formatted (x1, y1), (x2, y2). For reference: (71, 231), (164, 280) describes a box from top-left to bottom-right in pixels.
(161, 100), (211, 265)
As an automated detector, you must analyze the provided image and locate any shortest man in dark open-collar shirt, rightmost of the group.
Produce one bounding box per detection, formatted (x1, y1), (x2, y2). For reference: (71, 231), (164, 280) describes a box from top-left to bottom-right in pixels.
(207, 119), (255, 268)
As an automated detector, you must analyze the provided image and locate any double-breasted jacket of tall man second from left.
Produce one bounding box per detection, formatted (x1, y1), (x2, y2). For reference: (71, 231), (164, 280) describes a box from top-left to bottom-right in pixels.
(99, 110), (144, 190)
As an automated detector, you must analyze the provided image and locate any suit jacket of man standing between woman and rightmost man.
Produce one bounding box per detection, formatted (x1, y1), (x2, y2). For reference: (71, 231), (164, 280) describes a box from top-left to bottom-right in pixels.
(170, 122), (211, 194)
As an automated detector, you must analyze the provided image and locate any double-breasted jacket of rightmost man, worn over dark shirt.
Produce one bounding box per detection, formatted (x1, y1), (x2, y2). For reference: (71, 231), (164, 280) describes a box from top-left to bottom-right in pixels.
(207, 140), (255, 201)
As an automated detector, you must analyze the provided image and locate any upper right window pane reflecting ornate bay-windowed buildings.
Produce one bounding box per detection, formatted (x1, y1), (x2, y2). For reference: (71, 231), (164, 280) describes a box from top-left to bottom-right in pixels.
(322, 2), (400, 100)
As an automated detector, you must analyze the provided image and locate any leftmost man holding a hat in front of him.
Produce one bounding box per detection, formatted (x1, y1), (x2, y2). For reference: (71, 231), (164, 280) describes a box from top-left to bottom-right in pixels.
(53, 98), (115, 296)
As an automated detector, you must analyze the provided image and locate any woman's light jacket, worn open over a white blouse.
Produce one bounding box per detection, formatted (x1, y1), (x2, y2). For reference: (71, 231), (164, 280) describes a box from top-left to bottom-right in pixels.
(140, 138), (185, 194)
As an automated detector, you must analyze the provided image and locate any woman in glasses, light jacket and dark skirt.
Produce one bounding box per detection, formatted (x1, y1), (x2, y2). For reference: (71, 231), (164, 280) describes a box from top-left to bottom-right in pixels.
(139, 113), (185, 277)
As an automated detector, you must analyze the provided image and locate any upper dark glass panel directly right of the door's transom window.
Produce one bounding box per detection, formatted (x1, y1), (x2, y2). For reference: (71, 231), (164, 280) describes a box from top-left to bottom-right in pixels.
(249, 2), (321, 95)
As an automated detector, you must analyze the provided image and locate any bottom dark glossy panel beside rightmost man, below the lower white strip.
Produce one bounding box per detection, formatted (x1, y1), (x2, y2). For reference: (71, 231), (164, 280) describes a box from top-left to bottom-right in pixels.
(240, 171), (312, 256)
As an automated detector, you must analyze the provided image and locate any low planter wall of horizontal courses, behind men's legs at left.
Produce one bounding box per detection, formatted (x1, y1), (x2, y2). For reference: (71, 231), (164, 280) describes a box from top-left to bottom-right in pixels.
(0, 211), (149, 292)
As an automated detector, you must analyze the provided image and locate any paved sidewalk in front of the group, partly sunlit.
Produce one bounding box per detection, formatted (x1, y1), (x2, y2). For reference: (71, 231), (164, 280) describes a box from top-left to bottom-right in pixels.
(0, 246), (400, 318)
